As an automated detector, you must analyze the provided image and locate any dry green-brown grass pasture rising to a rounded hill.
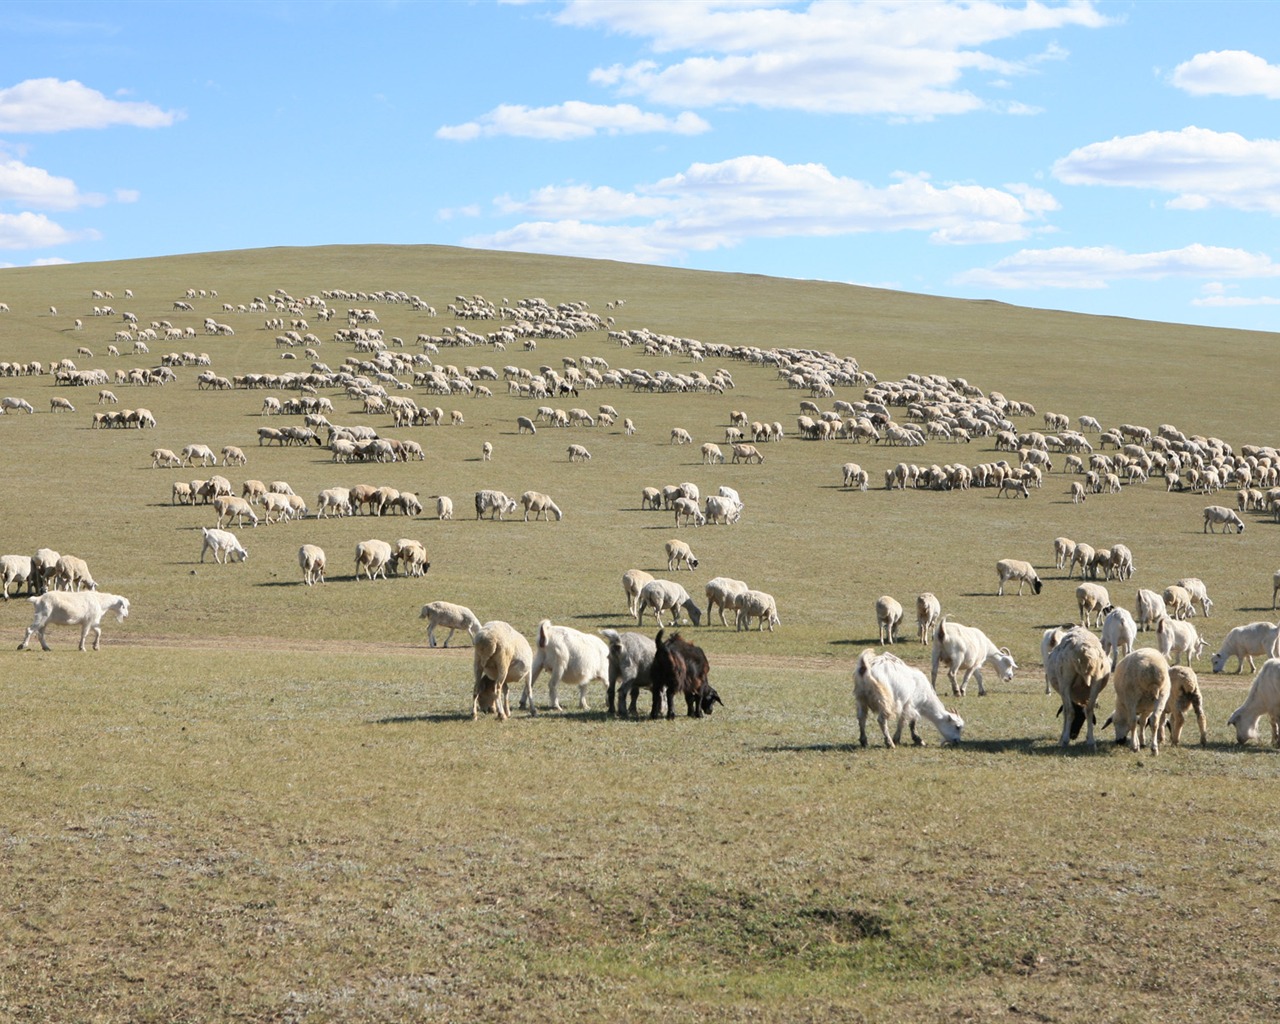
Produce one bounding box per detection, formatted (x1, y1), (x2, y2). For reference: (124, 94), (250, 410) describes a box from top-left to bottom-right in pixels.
(0, 246), (1280, 1021)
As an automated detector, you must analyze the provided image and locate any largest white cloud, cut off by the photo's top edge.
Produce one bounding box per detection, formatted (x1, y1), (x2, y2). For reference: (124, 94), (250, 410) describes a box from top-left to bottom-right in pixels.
(558, 0), (1108, 119)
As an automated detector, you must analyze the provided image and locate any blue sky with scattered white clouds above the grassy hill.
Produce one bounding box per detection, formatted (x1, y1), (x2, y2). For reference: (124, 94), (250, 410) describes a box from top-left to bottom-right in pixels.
(0, 0), (1280, 330)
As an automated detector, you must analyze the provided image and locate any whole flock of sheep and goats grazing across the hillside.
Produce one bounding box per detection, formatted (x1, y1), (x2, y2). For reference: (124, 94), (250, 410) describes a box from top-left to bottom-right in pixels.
(0, 271), (1280, 753)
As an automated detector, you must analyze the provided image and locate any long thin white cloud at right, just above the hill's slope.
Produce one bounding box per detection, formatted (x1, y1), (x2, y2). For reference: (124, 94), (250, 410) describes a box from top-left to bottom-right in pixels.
(955, 244), (1280, 289)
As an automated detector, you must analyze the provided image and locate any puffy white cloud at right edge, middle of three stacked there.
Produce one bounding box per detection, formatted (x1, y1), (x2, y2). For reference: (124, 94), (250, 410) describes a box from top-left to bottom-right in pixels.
(1053, 125), (1280, 214)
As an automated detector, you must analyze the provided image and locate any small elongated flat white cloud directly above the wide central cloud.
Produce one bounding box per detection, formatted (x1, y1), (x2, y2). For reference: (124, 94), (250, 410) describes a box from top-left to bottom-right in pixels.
(435, 100), (710, 142)
